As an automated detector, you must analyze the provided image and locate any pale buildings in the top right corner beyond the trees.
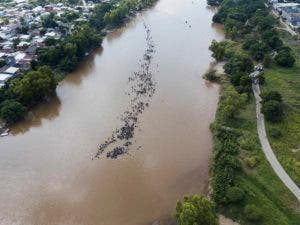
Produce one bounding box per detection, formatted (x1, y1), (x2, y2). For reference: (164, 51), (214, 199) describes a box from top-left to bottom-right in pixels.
(270, 0), (300, 29)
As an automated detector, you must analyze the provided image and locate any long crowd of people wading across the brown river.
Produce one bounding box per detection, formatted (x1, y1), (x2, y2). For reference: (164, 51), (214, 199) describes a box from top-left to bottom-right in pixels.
(95, 23), (156, 159)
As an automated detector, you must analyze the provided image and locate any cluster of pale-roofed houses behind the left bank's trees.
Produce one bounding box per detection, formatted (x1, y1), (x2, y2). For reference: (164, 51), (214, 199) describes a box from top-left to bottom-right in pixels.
(0, 0), (94, 87)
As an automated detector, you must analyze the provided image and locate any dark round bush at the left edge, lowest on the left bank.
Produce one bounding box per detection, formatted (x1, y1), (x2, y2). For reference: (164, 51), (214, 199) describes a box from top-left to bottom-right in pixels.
(0, 100), (27, 124)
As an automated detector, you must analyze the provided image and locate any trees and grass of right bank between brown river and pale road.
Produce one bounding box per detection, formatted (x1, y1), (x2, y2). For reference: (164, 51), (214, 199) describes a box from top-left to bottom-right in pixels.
(206, 0), (300, 225)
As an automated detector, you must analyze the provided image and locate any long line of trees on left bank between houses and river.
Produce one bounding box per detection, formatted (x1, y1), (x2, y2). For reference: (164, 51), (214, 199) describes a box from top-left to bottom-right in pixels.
(0, 0), (156, 125)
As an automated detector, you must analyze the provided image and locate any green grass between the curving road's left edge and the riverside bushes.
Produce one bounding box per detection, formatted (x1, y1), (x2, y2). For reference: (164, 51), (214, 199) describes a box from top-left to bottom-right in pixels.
(217, 78), (300, 225)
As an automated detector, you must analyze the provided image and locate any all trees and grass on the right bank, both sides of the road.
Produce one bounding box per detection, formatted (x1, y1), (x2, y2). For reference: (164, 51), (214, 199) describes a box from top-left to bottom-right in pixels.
(173, 0), (300, 225)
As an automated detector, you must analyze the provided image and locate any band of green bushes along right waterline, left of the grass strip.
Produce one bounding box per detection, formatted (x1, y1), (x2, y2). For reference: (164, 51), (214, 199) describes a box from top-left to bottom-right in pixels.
(212, 86), (263, 224)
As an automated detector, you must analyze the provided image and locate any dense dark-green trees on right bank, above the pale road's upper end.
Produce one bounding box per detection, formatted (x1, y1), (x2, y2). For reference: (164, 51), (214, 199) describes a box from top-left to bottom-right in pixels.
(213, 0), (295, 67)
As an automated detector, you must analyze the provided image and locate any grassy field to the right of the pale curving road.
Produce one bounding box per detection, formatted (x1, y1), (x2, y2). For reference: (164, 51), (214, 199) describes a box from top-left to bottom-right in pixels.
(262, 33), (300, 186)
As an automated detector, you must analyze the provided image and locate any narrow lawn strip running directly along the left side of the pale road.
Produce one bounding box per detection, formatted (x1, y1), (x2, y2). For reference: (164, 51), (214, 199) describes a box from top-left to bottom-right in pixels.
(240, 99), (300, 224)
